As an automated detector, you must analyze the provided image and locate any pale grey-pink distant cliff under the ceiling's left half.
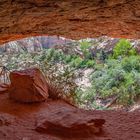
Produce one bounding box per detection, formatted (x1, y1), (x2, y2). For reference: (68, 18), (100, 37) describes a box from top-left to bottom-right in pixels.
(0, 36), (72, 54)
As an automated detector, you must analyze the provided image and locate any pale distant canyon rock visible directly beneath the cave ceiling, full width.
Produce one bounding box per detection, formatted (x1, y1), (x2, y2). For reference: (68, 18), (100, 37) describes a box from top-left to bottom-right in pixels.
(0, 36), (140, 55)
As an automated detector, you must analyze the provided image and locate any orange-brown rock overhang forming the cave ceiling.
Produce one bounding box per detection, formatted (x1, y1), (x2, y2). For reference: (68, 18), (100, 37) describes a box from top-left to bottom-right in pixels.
(0, 0), (140, 43)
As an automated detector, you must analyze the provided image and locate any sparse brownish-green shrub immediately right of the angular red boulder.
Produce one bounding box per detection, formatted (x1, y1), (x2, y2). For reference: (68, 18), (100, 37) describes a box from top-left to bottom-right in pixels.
(43, 60), (80, 102)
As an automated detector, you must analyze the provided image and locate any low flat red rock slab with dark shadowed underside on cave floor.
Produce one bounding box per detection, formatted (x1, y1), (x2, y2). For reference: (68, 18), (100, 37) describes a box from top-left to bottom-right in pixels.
(36, 109), (105, 138)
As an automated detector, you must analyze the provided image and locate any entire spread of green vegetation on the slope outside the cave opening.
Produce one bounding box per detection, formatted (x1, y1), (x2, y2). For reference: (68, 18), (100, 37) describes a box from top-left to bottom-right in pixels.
(1, 39), (140, 109)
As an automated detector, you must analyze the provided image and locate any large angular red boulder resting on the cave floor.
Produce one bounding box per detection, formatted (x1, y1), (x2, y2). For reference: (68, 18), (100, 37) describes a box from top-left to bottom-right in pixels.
(9, 68), (48, 103)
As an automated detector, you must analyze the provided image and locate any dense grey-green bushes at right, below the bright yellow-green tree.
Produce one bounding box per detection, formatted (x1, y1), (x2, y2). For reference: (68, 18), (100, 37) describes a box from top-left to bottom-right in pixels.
(81, 56), (140, 105)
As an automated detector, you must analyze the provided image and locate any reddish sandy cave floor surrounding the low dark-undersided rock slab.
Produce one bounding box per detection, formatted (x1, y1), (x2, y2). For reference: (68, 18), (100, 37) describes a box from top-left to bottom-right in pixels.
(0, 94), (140, 140)
